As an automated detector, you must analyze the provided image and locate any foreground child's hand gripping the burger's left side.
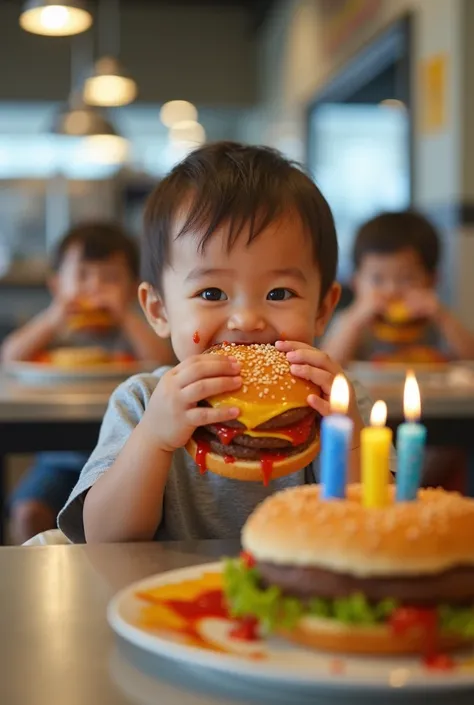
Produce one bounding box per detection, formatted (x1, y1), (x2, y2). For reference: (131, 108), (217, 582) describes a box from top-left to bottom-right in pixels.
(142, 355), (242, 453)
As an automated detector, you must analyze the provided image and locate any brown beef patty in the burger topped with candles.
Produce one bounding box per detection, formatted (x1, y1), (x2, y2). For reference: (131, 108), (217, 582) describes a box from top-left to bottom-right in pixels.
(257, 562), (474, 607)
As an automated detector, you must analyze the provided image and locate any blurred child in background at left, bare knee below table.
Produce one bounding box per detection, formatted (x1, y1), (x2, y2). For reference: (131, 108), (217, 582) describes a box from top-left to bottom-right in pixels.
(2, 222), (173, 543)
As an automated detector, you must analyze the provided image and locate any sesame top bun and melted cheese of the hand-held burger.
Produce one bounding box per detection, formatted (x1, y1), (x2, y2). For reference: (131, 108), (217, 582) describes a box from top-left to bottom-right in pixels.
(207, 343), (321, 428)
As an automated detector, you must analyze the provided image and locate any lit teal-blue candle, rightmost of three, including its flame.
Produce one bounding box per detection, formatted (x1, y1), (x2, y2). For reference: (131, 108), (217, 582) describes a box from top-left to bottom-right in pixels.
(396, 372), (426, 502)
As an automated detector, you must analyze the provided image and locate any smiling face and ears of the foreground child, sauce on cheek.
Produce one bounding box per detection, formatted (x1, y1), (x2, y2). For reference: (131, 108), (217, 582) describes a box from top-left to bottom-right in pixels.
(140, 217), (339, 360)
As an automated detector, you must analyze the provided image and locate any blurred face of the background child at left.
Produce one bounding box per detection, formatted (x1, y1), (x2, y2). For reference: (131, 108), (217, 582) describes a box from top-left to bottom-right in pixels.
(52, 245), (136, 306)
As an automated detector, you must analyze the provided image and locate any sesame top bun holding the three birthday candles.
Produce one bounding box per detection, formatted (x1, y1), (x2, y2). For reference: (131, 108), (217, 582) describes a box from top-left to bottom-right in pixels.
(242, 485), (474, 578)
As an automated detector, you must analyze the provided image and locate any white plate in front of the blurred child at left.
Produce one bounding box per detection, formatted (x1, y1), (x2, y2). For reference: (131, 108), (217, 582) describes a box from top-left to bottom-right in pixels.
(3, 362), (156, 384)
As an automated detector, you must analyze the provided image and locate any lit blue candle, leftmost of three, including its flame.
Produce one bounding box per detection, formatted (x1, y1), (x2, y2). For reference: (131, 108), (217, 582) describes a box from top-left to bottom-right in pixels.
(320, 375), (354, 499)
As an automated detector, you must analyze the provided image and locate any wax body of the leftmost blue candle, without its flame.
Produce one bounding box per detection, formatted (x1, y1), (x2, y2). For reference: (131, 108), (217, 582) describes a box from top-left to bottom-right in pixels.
(320, 414), (354, 499)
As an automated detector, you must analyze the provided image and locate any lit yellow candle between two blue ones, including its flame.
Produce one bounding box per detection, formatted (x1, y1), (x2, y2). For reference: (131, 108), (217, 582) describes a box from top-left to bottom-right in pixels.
(360, 401), (392, 507)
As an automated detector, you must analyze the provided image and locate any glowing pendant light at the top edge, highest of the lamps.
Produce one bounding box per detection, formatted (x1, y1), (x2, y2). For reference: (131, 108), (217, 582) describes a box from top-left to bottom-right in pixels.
(20, 0), (92, 37)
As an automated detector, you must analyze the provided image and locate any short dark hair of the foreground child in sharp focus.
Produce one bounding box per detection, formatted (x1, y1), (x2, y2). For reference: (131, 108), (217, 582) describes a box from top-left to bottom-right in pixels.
(142, 142), (338, 297)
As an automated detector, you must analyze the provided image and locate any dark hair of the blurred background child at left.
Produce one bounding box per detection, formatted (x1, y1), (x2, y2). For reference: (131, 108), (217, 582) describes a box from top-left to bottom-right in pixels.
(52, 221), (140, 279)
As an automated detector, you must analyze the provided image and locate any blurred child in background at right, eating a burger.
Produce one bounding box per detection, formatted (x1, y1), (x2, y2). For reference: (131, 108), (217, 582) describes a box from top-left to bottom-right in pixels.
(323, 211), (474, 486)
